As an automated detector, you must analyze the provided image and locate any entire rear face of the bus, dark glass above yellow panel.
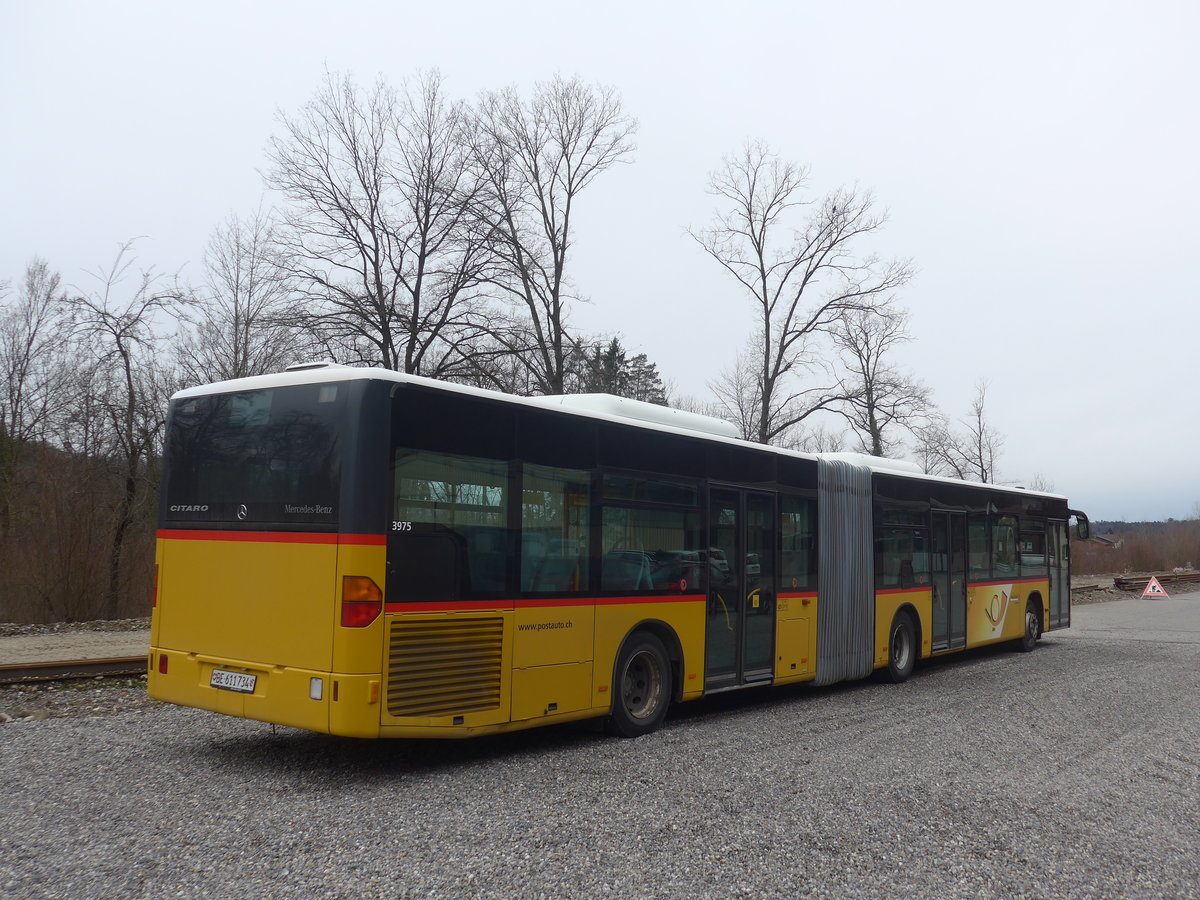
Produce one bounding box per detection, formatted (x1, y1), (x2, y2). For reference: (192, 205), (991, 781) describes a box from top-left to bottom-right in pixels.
(150, 382), (385, 736)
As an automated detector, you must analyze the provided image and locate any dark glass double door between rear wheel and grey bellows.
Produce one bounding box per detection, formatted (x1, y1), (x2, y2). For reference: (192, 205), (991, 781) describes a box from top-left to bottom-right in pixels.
(704, 487), (775, 690)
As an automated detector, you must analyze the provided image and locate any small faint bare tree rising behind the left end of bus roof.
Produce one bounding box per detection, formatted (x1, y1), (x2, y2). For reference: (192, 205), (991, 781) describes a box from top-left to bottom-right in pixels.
(176, 210), (305, 384)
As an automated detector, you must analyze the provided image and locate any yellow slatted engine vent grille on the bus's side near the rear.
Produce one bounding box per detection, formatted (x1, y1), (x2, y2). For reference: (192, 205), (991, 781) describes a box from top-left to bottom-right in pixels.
(388, 618), (504, 716)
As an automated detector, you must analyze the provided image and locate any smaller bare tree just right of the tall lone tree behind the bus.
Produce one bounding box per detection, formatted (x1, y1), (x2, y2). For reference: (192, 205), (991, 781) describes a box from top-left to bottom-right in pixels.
(832, 302), (932, 456)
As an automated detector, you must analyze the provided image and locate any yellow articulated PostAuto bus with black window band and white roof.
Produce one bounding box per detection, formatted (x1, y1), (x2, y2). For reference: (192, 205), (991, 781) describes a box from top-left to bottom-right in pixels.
(149, 364), (1086, 738)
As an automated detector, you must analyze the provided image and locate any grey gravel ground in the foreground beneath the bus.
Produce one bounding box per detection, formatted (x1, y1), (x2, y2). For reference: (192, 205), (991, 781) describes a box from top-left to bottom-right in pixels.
(0, 593), (1200, 899)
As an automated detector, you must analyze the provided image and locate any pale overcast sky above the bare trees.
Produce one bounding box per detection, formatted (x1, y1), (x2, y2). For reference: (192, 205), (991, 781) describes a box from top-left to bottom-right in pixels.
(0, 0), (1200, 520)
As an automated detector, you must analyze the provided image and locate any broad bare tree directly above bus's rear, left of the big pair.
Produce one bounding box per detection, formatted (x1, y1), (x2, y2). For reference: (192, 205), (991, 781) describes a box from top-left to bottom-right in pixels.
(268, 72), (484, 377)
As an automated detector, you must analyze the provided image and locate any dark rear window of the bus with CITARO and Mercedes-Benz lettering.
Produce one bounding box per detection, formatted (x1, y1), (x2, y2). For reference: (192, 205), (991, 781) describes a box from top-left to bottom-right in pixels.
(162, 384), (344, 526)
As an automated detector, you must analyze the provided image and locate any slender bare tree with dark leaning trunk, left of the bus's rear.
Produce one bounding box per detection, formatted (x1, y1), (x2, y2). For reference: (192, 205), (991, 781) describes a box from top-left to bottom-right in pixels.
(67, 241), (176, 617)
